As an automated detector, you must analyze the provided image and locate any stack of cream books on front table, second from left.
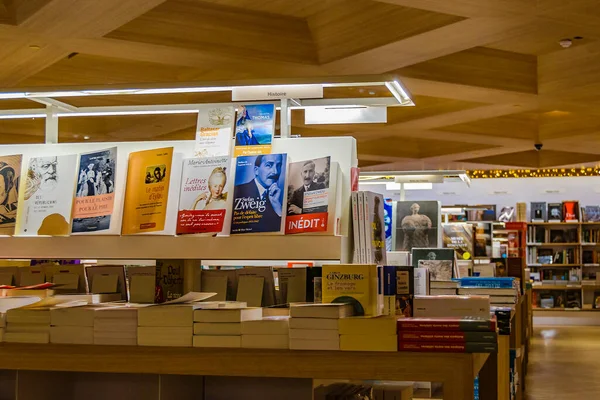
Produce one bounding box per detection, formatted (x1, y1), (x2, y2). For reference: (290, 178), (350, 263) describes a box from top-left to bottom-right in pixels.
(50, 306), (96, 344)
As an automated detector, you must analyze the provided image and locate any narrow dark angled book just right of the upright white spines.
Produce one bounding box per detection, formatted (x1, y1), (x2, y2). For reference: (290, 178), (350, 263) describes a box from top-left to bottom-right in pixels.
(364, 192), (387, 265)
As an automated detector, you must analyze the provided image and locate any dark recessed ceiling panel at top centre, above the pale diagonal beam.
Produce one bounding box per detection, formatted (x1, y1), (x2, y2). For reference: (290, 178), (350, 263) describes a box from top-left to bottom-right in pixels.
(308, 0), (463, 63)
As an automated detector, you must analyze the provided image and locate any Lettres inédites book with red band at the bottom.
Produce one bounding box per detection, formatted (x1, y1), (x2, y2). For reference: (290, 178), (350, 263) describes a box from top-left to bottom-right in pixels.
(177, 157), (230, 235)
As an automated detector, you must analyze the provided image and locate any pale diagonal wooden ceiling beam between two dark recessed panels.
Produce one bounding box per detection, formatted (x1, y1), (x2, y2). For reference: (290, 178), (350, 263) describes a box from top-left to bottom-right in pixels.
(324, 17), (532, 74)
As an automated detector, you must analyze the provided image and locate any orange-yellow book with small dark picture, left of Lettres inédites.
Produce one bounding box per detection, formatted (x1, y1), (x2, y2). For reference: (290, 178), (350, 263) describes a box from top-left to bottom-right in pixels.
(121, 147), (173, 235)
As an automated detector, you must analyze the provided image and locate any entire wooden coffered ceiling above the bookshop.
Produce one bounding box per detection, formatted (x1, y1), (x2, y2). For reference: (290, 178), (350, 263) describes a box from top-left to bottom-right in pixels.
(0, 0), (600, 170)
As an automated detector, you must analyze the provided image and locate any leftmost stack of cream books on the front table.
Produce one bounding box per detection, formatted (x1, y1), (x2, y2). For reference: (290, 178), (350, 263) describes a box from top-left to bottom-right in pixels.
(4, 307), (50, 343)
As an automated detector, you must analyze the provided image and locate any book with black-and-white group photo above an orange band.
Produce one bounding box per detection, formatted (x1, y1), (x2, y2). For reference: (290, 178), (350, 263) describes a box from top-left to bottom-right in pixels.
(71, 147), (117, 233)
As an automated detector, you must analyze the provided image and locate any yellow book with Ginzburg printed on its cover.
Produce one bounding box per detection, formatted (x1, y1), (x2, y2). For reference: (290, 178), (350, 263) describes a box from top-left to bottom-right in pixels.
(322, 265), (383, 316)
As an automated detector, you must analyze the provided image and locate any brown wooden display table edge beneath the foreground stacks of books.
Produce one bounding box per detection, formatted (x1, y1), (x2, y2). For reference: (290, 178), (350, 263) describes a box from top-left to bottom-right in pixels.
(0, 343), (496, 400)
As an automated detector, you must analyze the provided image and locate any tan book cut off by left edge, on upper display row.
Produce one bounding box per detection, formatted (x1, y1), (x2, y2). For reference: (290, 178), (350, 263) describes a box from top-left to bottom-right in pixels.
(0, 154), (23, 235)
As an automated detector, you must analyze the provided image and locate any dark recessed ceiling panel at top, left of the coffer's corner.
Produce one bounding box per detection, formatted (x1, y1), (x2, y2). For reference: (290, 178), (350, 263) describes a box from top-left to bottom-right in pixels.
(107, 0), (316, 64)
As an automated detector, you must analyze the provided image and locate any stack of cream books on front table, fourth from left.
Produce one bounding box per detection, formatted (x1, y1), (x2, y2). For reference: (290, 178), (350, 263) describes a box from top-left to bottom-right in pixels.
(137, 303), (196, 347)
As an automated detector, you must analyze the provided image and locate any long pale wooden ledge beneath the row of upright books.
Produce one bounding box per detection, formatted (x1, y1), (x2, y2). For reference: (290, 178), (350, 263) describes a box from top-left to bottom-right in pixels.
(0, 235), (350, 262)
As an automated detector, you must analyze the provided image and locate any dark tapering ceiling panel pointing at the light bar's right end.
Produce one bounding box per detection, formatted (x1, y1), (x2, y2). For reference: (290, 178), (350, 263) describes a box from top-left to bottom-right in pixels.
(394, 47), (537, 93)
